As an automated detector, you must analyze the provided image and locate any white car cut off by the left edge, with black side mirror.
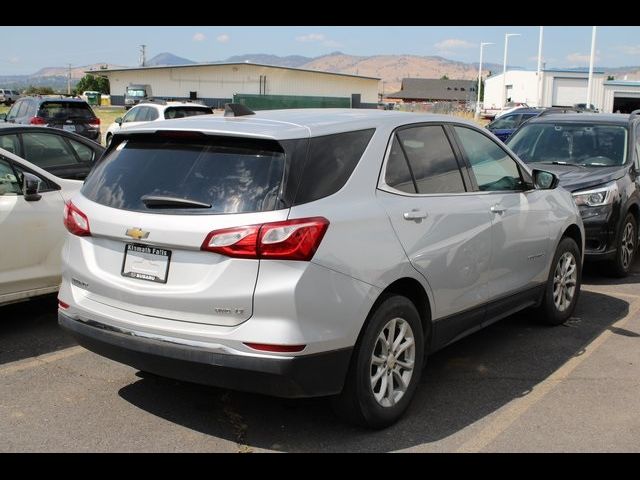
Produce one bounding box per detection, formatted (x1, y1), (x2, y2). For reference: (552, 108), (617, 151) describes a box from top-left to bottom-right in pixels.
(0, 148), (82, 305)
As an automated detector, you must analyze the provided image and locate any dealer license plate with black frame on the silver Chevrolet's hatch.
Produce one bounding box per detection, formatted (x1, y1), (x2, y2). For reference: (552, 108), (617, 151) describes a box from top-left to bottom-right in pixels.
(122, 243), (171, 283)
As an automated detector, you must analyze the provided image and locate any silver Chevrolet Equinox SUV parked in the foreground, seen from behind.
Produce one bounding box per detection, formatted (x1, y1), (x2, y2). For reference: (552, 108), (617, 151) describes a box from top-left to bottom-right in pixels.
(59, 108), (584, 428)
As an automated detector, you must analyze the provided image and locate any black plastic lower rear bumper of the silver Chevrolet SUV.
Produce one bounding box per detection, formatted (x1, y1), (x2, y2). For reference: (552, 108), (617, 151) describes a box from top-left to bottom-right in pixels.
(58, 311), (352, 398)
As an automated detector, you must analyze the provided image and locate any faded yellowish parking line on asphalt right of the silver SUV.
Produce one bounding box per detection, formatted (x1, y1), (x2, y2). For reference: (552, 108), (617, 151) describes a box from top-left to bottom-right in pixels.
(456, 295), (640, 453)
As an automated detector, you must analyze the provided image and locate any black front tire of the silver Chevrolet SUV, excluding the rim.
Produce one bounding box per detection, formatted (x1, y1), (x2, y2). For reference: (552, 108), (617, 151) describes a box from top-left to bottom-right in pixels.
(538, 237), (582, 325)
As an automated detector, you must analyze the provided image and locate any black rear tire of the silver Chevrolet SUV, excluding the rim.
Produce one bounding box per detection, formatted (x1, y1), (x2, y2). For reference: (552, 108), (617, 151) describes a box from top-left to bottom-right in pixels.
(332, 295), (424, 428)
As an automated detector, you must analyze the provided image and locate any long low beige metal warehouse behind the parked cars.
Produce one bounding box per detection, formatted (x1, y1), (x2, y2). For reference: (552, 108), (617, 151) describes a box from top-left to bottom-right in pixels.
(86, 62), (379, 110)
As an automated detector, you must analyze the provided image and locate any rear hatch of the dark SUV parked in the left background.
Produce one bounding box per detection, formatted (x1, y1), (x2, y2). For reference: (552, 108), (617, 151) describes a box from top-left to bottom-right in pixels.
(37, 100), (100, 140)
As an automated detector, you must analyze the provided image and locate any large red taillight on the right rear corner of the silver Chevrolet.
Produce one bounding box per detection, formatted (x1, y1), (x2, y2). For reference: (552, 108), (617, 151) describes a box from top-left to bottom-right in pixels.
(201, 217), (329, 261)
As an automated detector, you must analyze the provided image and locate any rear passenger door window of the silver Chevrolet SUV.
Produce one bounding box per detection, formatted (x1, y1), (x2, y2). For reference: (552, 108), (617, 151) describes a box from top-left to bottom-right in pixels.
(396, 125), (465, 194)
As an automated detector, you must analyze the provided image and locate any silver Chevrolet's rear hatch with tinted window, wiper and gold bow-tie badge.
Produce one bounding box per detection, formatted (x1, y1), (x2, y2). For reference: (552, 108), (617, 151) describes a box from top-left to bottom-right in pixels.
(74, 132), (289, 326)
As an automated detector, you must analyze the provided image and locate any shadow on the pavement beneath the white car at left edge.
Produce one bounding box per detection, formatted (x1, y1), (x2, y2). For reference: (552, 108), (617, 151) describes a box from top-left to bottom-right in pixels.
(0, 294), (76, 365)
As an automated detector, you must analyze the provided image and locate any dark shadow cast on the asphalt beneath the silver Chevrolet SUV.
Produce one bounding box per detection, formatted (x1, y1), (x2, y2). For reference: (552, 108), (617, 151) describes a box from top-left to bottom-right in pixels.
(119, 291), (629, 451)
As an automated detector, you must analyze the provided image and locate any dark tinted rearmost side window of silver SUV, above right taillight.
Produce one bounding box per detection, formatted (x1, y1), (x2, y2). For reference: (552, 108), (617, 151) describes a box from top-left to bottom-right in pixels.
(294, 128), (375, 205)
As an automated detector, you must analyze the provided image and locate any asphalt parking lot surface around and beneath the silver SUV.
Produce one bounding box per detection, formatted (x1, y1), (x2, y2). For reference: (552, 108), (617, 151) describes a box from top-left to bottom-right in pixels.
(0, 262), (640, 452)
